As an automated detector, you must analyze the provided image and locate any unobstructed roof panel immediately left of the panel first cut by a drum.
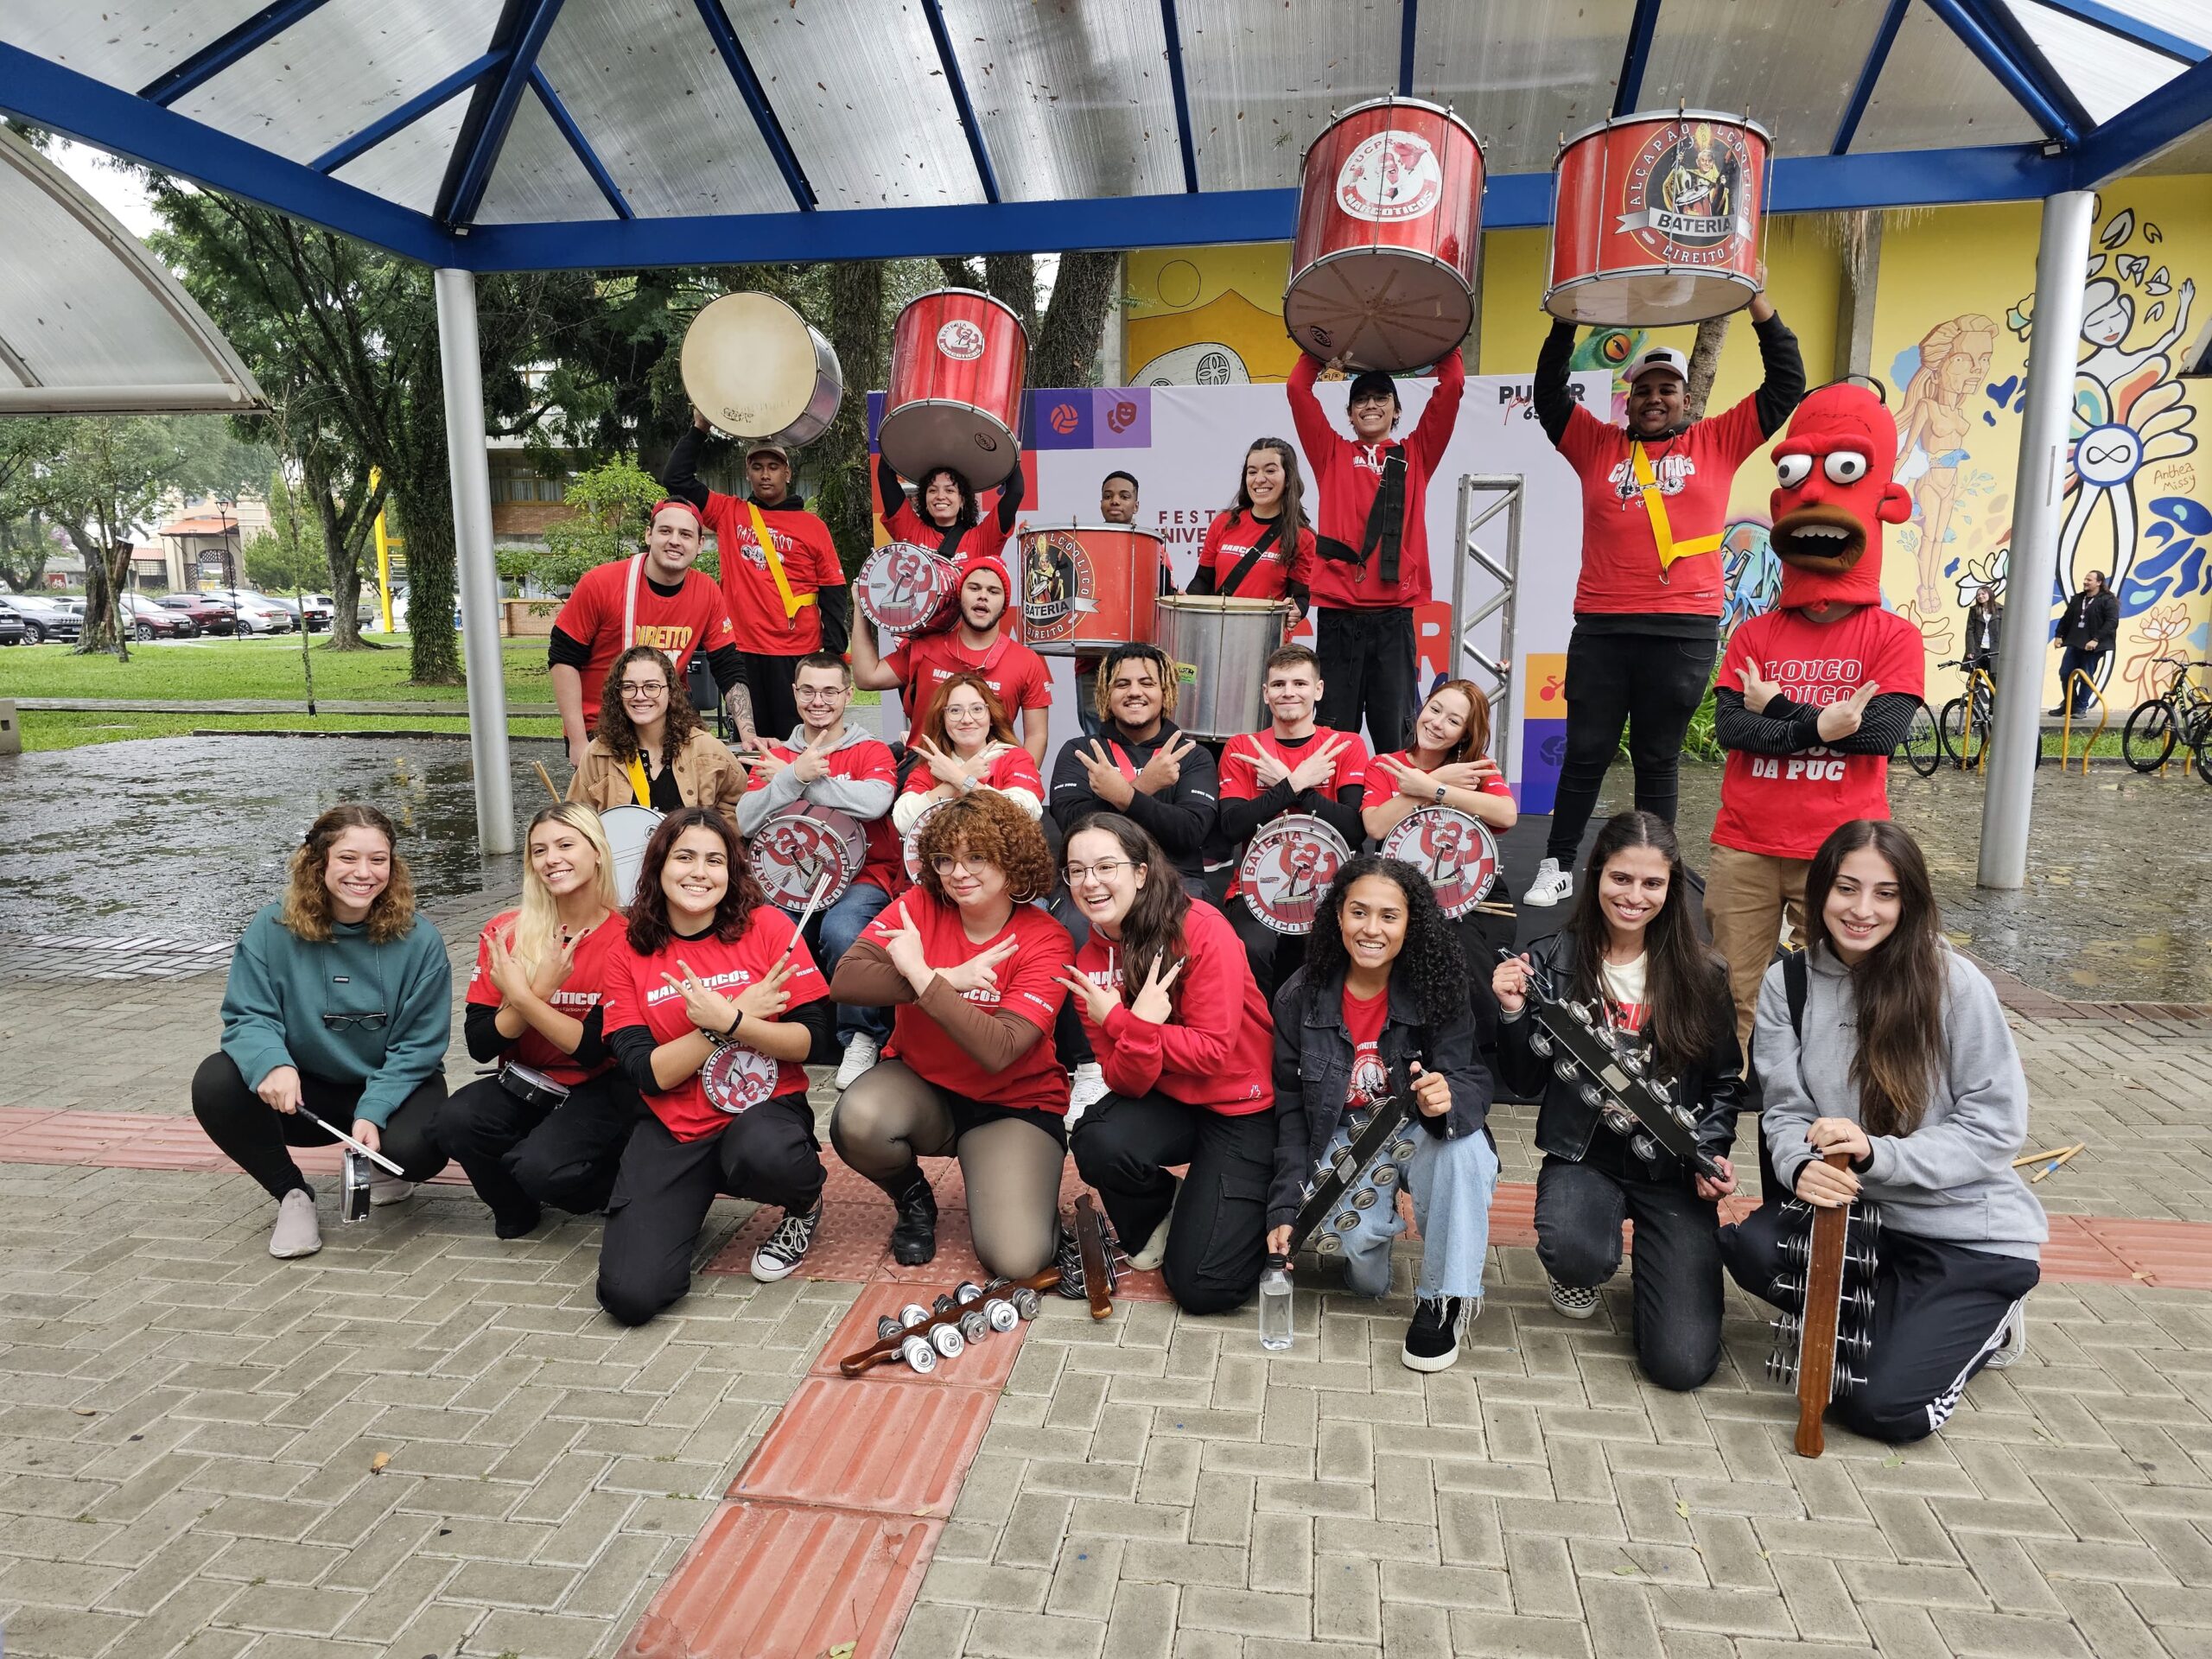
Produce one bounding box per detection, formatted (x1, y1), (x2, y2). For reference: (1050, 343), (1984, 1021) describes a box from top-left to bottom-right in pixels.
(944, 0), (1184, 201)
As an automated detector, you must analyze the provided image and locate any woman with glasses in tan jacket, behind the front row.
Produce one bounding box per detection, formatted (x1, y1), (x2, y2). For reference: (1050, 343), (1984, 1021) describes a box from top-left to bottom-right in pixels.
(569, 646), (746, 836)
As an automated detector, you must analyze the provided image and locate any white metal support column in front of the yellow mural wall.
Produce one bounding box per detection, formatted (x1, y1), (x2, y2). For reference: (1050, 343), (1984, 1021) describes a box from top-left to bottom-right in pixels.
(1975, 190), (2097, 887)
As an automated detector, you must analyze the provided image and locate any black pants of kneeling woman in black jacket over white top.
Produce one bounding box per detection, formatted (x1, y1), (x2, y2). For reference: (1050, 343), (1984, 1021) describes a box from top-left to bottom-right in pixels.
(1535, 1159), (1721, 1389)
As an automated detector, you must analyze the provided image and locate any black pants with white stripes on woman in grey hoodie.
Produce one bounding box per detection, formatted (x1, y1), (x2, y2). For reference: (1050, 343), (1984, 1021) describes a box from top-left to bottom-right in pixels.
(1725, 1201), (2042, 1442)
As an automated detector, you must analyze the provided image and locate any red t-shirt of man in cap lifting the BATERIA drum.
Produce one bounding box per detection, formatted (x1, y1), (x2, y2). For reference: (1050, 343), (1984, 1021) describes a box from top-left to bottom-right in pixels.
(1560, 398), (1767, 617)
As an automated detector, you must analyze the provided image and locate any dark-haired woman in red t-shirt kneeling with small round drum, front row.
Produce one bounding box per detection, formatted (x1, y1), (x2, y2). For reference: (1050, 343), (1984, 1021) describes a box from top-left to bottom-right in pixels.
(600, 807), (830, 1325)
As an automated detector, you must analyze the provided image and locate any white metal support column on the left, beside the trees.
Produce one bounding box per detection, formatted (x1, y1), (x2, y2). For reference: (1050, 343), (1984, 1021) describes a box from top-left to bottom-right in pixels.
(431, 270), (515, 852)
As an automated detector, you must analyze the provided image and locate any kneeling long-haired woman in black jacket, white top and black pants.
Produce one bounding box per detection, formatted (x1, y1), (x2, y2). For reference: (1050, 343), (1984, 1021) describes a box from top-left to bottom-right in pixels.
(1491, 812), (1743, 1389)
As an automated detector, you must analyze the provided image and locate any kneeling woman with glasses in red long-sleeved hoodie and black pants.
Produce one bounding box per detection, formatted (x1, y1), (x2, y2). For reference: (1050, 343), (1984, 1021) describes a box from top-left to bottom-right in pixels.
(1062, 812), (1276, 1314)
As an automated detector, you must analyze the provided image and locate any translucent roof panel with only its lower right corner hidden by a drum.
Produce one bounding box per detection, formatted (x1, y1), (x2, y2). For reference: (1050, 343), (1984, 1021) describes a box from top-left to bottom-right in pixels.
(1177, 0), (1400, 190)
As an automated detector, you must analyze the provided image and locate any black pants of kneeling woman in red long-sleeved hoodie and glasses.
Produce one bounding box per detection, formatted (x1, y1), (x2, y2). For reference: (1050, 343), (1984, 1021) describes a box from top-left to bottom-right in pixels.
(1068, 1093), (1274, 1314)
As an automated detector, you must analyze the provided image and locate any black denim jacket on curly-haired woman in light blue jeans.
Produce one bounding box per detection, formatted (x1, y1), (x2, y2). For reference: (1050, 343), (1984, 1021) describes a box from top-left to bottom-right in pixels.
(1268, 969), (1496, 1228)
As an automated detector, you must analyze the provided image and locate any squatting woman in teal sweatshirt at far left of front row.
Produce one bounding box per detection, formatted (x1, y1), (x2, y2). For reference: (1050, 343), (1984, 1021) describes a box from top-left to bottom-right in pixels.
(193, 805), (453, 1259)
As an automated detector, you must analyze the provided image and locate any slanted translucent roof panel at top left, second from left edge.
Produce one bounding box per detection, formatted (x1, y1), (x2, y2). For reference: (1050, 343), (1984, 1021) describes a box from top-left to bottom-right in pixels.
(170, 0), (500, 162)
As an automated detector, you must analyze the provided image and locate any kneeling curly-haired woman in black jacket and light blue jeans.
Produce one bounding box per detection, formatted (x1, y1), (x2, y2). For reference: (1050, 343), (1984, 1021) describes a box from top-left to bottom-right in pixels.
(1268, 852), (1497, 1371)
